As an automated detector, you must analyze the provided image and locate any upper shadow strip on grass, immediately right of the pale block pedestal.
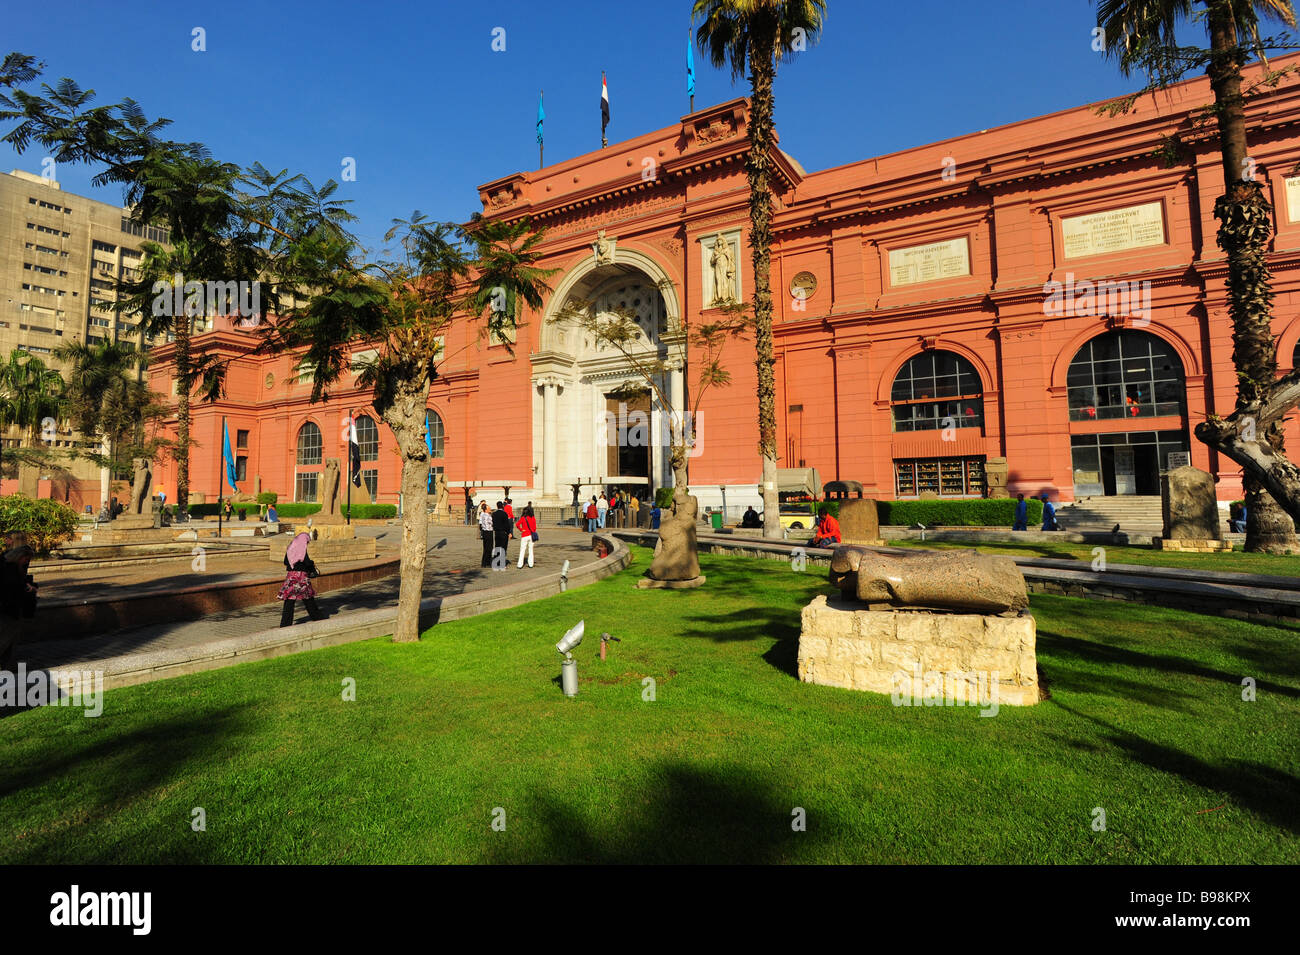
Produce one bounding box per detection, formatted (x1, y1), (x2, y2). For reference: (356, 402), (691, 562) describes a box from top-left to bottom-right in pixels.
(1039, 630), (1300, 709)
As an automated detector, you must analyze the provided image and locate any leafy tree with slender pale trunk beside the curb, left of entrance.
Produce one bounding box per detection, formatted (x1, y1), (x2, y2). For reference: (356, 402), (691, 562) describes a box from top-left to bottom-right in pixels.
(284, 213), (550, 643)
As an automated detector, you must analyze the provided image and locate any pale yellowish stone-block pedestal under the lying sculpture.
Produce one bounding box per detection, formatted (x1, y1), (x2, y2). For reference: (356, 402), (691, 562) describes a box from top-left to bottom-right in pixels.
(798, 595), (1041, 711)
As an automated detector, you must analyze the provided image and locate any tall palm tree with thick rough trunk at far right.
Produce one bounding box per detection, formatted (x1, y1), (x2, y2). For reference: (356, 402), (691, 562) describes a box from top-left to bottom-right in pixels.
(1097, 0), (1296, 554)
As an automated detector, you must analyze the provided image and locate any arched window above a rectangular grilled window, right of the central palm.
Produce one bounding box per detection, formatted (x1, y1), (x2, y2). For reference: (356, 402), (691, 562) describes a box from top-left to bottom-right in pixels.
(889, 351), (984, 431)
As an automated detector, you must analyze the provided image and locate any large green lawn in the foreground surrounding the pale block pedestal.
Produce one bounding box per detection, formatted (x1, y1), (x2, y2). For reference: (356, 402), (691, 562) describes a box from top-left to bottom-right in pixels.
(0, 550), (1300, 864)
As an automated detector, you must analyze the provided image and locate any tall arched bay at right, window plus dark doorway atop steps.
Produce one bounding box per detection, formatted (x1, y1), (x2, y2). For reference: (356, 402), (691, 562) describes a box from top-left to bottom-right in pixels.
(1066, 330), (1191, 498)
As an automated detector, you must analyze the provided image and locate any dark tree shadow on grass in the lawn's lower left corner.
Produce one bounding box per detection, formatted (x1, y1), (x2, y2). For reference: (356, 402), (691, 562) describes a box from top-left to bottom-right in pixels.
(0, 707), (246, 864)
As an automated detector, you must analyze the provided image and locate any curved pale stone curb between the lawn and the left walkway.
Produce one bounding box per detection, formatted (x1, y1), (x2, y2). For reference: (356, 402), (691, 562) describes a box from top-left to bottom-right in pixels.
(51, 535), (632, 689)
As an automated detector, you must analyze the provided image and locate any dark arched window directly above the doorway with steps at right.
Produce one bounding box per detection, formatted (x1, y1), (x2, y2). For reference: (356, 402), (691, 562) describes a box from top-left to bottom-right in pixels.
(1066, 329), (1183, 421)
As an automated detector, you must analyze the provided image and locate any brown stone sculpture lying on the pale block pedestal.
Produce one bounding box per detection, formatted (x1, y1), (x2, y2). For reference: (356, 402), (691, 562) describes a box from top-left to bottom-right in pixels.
(831, 546), (1030, 613)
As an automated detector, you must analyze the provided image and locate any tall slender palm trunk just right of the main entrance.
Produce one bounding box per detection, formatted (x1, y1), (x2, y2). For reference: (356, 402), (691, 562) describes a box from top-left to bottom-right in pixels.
(745, 34), (783, 539)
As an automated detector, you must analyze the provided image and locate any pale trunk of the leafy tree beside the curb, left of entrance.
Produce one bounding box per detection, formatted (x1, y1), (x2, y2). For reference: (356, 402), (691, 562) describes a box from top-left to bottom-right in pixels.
(384, 379), (429, 643)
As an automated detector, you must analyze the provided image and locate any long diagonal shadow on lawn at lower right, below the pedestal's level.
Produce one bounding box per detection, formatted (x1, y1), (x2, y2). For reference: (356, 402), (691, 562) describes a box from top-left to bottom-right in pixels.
(1056, 700), (1300, 833)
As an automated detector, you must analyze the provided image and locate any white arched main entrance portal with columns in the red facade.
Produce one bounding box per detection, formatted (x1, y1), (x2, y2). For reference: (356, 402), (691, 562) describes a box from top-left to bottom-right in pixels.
(532, 249), (685, 504)
